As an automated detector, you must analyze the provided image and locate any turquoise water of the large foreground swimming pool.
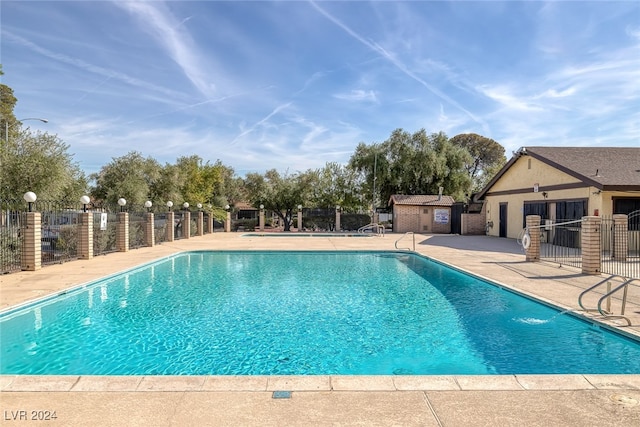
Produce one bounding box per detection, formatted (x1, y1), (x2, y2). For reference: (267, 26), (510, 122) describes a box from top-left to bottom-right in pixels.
(0, 252), (640, 375)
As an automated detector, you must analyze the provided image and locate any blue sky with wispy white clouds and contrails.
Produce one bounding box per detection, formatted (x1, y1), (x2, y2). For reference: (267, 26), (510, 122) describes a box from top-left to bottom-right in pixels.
(0, 0), (640, 176)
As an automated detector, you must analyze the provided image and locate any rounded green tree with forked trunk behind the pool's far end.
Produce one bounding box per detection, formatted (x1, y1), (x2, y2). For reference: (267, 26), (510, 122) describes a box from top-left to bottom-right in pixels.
(244, 169), (313, 231)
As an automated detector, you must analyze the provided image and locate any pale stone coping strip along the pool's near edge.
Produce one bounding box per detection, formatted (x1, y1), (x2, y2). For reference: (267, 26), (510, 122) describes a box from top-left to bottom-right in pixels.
(0, 374), (640, 392)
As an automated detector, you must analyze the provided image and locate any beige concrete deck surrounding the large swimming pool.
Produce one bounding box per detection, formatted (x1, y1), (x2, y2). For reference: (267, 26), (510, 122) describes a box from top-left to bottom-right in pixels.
(0, 233), (640, 427)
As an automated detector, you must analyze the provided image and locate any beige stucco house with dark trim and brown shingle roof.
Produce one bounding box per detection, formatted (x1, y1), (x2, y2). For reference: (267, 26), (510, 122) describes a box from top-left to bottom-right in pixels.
(476, 147), (640, 238)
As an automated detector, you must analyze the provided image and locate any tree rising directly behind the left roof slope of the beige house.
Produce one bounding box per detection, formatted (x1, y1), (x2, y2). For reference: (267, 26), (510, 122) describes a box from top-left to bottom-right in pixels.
(450, 133), (507, 192)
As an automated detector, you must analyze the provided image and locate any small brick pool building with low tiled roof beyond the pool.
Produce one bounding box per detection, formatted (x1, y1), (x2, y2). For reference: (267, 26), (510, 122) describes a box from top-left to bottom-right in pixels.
(389, 194), (455, 233)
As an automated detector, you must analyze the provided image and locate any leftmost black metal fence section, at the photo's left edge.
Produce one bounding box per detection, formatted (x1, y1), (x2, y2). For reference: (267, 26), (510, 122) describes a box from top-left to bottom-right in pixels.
(0, 200), (25, 274)
